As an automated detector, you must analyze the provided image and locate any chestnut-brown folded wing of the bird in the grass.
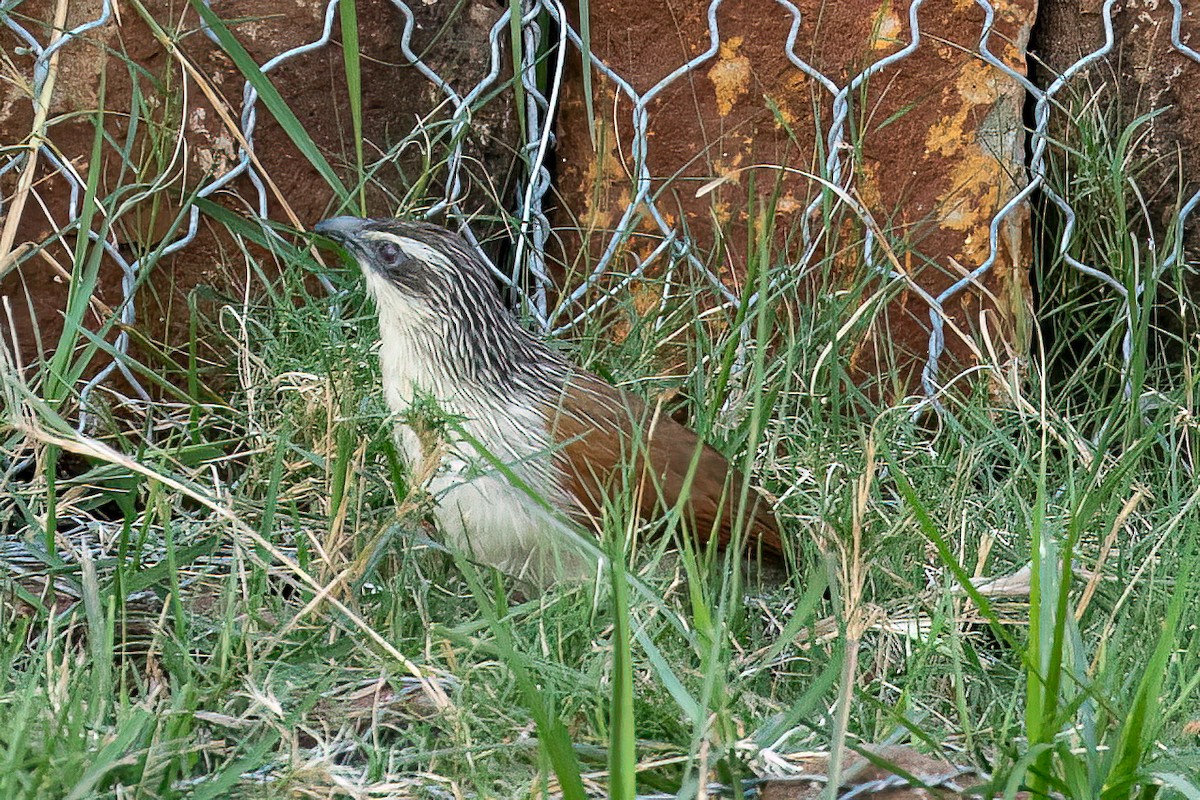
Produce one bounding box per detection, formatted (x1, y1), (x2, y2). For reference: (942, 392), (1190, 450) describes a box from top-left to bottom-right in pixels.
(548, 373), (784, 561)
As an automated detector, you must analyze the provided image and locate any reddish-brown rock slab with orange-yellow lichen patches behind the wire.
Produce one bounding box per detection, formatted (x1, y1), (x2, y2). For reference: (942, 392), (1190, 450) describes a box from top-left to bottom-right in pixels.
(559, 0), (1034, 393)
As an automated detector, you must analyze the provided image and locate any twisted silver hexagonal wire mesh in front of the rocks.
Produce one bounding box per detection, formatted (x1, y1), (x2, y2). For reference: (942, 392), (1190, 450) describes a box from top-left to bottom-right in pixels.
(0, 0), (1200, 427)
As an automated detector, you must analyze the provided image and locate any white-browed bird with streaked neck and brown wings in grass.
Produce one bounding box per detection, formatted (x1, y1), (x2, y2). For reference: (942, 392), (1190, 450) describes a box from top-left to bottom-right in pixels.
(313, 216), (785, 588)
